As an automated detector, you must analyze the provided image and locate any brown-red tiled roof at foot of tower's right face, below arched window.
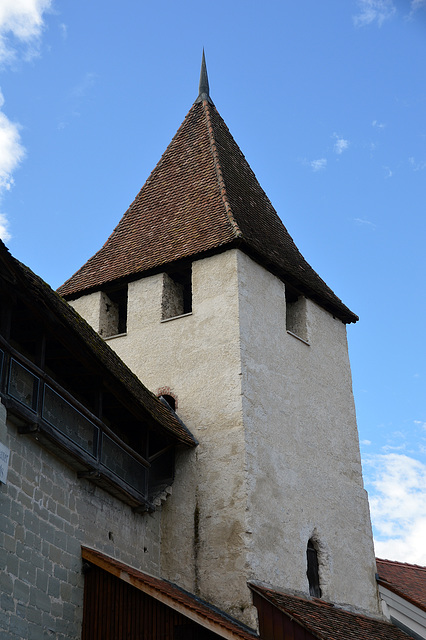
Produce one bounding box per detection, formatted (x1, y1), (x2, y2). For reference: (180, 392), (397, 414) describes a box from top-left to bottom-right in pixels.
(249, 584), (408, 640)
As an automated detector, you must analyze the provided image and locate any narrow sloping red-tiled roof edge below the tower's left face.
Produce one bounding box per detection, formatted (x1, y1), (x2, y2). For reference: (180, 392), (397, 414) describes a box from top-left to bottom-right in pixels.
(81, 547), (259, 640)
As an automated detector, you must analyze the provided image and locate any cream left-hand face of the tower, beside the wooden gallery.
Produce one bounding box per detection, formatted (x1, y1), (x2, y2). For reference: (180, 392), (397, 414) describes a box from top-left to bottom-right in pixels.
(95, 251), (256, 626)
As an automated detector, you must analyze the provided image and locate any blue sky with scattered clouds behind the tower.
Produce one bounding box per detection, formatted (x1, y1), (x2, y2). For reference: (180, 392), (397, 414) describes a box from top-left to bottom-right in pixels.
(0, 0), (426, 564)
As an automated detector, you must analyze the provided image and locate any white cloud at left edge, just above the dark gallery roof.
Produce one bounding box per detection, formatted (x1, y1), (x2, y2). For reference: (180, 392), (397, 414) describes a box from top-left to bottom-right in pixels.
(0, 90), (25, 241)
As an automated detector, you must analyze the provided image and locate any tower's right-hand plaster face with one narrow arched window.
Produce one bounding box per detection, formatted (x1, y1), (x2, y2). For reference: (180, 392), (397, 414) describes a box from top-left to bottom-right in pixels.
(238, 253), (379, 615)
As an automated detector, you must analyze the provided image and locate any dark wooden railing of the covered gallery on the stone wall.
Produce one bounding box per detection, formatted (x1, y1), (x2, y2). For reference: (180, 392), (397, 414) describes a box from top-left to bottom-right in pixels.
(0, 336), (153, 510)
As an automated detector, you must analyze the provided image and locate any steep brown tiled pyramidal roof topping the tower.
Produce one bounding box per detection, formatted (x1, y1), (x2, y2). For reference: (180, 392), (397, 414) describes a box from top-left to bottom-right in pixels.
(59, 59), (358, 322)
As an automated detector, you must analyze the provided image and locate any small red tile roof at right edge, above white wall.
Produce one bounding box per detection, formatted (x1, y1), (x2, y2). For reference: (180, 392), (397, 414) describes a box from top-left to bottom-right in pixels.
(376, 558), (426, 611)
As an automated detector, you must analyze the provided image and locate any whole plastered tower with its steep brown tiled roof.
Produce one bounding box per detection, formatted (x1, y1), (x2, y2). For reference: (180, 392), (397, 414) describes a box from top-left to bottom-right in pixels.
(59, 57), (379, 624)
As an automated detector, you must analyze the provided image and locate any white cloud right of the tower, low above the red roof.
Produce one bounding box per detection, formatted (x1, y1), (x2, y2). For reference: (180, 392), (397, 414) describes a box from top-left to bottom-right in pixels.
(363, 453), (426, 565)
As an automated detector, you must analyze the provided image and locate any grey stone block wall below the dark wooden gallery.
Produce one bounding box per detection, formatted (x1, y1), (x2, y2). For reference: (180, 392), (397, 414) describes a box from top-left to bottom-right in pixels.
(0, 403), (160, 640)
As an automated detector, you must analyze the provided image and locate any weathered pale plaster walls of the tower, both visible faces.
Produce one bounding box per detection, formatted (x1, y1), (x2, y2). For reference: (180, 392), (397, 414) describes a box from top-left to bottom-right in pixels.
(71, 250), (379, 625)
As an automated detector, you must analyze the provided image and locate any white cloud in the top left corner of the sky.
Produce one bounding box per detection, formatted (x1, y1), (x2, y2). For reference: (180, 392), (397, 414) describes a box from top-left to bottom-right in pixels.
(0, 0), (53, 63)
